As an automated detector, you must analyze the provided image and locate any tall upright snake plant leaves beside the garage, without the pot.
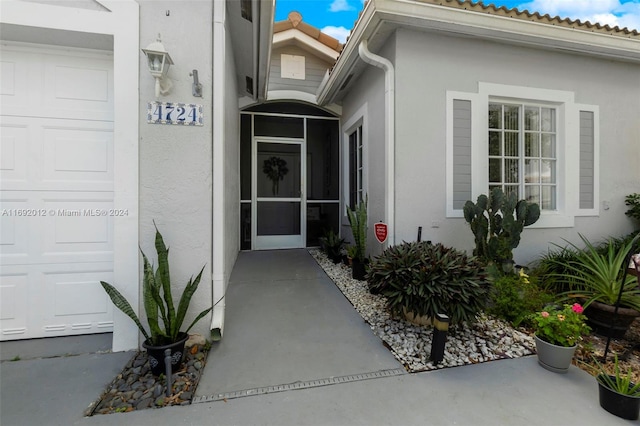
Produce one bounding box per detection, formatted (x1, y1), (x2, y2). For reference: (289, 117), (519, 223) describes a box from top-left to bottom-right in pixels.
(100, 223), (212, 346)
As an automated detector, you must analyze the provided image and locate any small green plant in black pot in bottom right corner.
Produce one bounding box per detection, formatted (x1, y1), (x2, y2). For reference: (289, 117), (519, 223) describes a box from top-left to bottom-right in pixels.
(596, 356), (640, 420)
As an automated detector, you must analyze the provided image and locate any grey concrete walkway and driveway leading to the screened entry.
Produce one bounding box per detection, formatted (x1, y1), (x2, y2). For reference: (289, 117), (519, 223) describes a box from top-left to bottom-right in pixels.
(0, 250), (640, 426)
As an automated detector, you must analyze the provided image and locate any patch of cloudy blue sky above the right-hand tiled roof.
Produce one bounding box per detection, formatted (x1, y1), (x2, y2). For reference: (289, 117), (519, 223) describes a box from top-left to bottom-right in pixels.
(518, 0), (640, 29)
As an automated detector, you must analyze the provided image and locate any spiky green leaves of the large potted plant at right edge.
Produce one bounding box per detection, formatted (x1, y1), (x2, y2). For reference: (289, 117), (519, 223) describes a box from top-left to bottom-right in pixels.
(550, 233), (640, 312)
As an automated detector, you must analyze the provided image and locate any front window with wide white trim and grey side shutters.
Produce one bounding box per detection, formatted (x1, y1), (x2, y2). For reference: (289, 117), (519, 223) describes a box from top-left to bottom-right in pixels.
(446, 83), (599, 227)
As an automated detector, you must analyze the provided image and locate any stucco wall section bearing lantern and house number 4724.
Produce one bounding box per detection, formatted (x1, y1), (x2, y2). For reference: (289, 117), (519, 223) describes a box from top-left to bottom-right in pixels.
(139, 1), (213, 336)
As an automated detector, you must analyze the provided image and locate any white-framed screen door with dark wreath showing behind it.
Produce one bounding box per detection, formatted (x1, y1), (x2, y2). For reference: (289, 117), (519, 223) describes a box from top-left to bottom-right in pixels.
(251, 138), (306, 250)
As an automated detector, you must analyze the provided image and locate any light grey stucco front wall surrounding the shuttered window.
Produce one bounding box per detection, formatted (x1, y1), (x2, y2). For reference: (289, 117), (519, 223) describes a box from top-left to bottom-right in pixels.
(396, 30), (640, 263)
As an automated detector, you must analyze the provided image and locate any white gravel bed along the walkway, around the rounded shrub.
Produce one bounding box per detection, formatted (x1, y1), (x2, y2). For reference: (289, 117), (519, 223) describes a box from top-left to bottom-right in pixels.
(309, 249), (535, 372)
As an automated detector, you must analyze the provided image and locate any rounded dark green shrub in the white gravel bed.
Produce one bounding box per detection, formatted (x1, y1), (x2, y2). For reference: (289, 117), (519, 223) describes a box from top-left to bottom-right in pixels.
(367, 242), (490, 325)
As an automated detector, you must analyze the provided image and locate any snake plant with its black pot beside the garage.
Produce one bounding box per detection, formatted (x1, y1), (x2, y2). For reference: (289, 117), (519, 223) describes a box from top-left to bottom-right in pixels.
(100, 223), (212, 376)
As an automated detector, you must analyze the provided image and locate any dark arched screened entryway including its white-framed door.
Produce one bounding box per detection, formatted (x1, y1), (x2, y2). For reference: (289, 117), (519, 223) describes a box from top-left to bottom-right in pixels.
(240, 102), (340, 250)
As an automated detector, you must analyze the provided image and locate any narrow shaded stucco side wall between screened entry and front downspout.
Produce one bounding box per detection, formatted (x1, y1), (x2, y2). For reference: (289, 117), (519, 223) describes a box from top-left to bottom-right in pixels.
(341, 37), (395, 256)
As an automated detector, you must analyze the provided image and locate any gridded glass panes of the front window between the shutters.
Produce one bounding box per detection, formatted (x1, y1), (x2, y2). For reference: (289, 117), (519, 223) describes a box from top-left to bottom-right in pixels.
(488, 102), (558, 211)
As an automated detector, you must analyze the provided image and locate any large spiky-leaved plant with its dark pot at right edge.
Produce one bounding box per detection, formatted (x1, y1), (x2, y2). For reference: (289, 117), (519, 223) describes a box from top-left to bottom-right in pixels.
(548, 233), (640, 337)
